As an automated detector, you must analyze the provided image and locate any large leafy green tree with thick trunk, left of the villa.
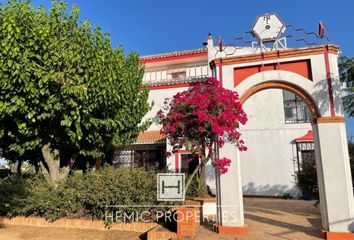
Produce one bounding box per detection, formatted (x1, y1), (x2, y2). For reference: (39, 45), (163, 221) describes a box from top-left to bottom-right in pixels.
(0, 0), (149, 182)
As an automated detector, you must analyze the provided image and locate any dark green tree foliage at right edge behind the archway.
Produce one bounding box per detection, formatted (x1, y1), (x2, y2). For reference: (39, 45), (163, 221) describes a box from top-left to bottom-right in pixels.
(339, 56), (354, 117)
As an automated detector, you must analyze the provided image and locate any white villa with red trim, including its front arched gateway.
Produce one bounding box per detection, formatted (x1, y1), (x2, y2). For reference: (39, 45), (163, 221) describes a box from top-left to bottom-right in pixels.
(114, 13), (354, 236)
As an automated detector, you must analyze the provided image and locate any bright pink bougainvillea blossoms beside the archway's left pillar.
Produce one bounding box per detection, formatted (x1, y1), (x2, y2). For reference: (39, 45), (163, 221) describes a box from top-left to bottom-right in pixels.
(157, 78), (247, 173)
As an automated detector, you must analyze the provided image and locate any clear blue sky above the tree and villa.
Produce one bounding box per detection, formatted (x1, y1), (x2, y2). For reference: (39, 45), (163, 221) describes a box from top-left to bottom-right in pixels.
(0, 0), (354, 136)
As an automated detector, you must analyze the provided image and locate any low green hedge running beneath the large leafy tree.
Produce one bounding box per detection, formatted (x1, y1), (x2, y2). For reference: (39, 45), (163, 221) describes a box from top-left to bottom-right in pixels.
(0, 166), (158, 220)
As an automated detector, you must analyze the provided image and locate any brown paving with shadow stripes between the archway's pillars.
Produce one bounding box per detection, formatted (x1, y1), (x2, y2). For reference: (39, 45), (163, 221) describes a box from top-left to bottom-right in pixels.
(196, 198), (321, 240)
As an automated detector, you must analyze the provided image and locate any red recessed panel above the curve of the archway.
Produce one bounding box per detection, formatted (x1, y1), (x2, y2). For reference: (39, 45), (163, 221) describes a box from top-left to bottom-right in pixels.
(234, 59), (312, 87)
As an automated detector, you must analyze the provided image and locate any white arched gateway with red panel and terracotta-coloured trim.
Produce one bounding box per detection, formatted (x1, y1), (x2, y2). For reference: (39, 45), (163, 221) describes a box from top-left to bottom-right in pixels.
(207, 15), (354, 239)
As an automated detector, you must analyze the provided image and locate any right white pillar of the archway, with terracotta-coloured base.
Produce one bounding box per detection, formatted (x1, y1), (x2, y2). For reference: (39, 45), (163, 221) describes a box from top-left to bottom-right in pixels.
(312, 117), (354, 235)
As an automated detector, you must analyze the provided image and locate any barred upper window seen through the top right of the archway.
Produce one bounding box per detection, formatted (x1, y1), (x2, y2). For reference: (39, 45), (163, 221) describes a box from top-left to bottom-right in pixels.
(283, 90), (311, 123)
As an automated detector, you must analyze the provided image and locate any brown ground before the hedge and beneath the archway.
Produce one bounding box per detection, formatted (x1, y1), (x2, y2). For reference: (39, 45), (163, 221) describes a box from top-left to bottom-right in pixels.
(0, 198), (321, 240)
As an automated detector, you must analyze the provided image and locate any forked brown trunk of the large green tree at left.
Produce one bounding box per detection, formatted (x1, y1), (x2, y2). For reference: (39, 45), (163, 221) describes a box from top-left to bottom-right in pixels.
(40, 143), (77, 184)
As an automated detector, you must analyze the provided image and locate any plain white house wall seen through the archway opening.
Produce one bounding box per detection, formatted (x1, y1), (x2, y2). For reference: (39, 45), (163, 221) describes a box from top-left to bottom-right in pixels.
(240, 89), (311, 196)
